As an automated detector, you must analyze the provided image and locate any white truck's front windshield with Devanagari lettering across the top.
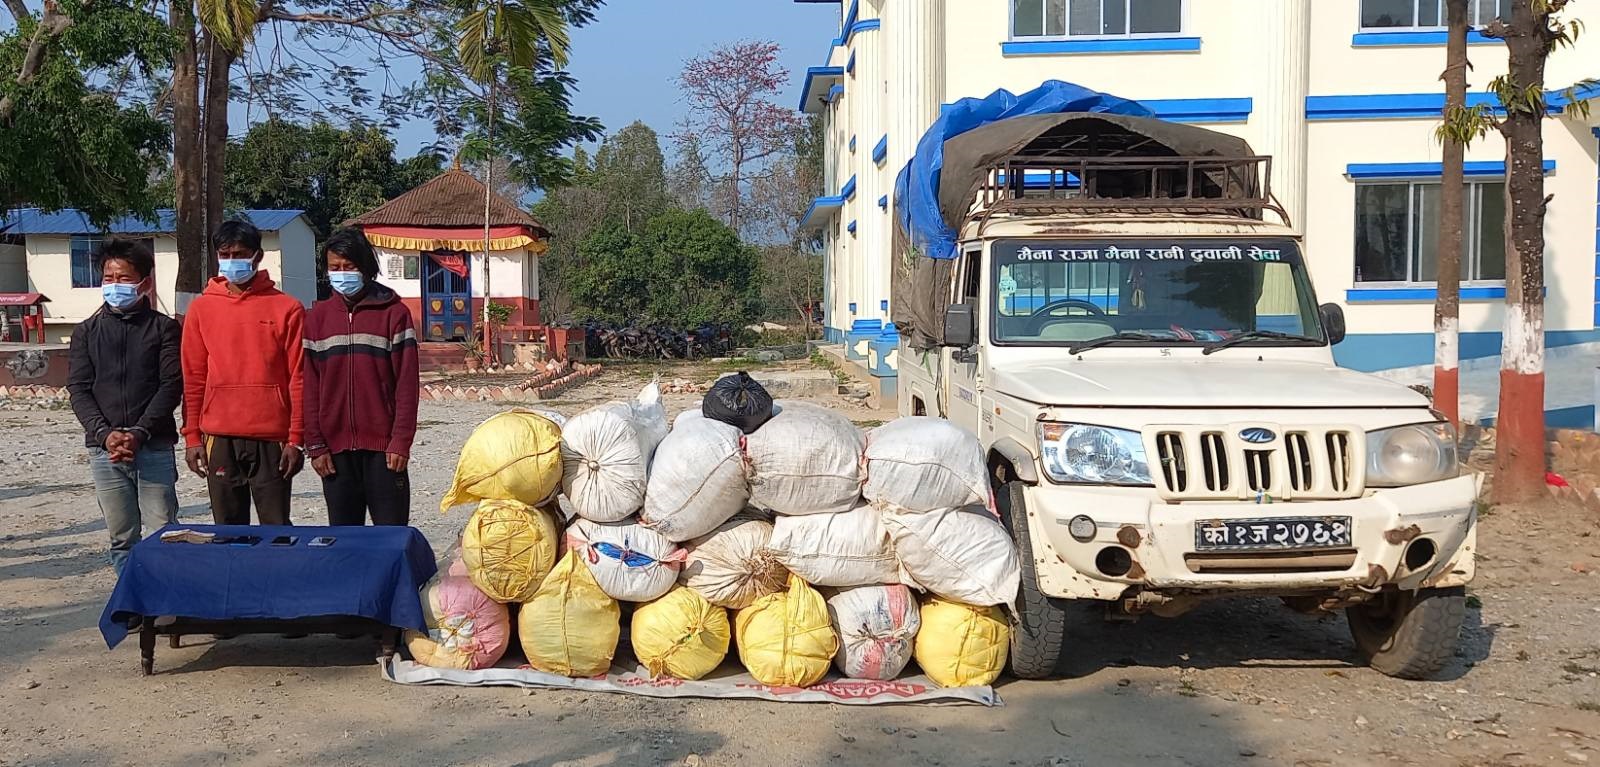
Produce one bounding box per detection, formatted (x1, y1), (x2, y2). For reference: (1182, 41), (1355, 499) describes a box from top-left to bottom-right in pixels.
(990, 239), (1326, 346)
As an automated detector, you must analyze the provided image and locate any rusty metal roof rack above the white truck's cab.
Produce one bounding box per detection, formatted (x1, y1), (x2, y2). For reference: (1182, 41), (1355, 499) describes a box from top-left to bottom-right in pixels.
(974, 155), (1290, 226)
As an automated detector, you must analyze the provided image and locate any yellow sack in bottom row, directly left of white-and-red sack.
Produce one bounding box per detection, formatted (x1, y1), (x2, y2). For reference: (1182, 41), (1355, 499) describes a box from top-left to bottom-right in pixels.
(734, 575), (838, 687)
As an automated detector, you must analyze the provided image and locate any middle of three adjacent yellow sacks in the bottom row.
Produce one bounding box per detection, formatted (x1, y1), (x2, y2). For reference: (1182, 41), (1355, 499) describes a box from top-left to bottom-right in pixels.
(632, 586), (733, 679)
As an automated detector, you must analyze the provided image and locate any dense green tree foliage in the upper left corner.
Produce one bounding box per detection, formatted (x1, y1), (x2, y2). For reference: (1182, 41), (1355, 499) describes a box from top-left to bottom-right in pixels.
(0, 5), (173, 223)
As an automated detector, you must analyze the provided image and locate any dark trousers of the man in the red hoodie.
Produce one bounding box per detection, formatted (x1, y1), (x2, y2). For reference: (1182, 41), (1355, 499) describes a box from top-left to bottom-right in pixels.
(205, 436), (290, 525)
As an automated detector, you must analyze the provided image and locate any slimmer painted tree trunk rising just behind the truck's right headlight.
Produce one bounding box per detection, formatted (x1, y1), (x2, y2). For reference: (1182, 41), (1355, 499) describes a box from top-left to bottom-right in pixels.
(1434, 0), (1474, 423)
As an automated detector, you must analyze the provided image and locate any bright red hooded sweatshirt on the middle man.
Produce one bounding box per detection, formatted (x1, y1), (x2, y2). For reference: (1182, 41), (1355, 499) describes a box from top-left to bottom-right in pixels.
(182, 271), (306, 447)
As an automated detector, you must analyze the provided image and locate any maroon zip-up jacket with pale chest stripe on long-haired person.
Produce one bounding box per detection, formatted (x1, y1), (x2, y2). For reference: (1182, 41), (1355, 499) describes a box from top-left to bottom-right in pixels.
(304, 282), (418, 458)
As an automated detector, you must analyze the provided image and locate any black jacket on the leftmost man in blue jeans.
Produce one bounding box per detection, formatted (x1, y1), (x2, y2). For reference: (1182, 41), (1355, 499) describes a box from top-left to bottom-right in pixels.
(67, 303), (184, 447)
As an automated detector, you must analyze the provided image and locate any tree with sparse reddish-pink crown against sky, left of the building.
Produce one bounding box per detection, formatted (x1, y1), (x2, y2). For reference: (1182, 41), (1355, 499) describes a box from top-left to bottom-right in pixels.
(677, 40), (798, 232)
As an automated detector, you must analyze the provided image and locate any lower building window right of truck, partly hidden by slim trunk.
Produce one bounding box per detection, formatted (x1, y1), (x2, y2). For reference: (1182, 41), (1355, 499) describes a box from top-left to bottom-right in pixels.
(1355, 181), (1506, 285)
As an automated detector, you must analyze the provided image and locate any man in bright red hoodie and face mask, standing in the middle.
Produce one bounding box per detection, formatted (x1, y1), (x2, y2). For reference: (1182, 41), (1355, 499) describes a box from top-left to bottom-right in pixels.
(182, 221), (306, 525)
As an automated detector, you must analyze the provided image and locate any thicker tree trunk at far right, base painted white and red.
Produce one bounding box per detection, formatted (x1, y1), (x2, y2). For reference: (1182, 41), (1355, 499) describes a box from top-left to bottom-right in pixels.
(1472, 0), (1597, 503)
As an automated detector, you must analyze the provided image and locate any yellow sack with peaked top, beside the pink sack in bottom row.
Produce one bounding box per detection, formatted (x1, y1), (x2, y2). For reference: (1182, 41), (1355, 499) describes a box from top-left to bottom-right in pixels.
(517, 552), (622, 677)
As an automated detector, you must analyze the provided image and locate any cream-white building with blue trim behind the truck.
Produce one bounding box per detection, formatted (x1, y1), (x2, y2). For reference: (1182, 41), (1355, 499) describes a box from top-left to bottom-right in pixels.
(797, 0), (1600, 423)
